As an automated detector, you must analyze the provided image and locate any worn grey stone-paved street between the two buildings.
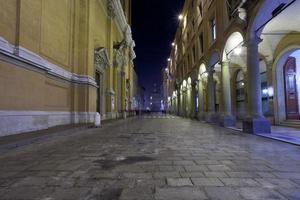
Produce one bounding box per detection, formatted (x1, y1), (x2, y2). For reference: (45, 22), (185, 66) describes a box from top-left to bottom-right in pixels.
(0, 117), (300, 200)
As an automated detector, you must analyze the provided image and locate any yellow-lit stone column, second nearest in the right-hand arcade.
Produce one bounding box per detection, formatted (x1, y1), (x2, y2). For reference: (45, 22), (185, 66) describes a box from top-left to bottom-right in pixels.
(220, 60), (236, 127)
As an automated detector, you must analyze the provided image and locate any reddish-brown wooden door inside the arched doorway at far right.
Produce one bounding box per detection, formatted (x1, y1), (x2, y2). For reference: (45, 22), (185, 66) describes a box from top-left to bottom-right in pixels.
(284, 57), (300, 120)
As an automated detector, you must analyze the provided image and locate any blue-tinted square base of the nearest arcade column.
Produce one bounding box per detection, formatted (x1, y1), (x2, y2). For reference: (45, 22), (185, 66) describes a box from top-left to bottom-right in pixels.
(243, 117), (271, 134)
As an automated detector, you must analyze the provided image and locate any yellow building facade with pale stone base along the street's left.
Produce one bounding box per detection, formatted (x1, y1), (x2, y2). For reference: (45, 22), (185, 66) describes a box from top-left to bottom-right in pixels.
(0, 0), (135, 136)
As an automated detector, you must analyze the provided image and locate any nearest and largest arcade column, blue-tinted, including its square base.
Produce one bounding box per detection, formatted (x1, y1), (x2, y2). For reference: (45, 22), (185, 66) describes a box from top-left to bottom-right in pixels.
(243, 37), (271, 134)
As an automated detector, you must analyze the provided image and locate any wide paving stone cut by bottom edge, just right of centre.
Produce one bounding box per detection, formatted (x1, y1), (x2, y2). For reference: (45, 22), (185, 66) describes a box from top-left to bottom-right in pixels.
(155, 187), (208, 200)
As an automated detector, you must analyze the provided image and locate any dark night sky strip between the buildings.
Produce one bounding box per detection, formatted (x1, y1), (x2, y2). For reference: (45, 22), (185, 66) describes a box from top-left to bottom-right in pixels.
(132, 0), (184, 94)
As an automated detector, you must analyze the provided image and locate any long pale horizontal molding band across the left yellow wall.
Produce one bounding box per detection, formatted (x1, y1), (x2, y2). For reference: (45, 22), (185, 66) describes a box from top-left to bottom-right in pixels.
(0, 37), (98, 87)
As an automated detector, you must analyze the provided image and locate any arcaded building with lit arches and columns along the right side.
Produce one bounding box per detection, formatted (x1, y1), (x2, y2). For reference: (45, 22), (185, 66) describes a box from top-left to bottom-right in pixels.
(168, 0), (300, 133)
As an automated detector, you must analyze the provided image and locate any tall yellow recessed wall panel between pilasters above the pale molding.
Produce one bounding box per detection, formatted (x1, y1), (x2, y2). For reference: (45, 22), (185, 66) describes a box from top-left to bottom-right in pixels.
(41, 0), (72, 70)
